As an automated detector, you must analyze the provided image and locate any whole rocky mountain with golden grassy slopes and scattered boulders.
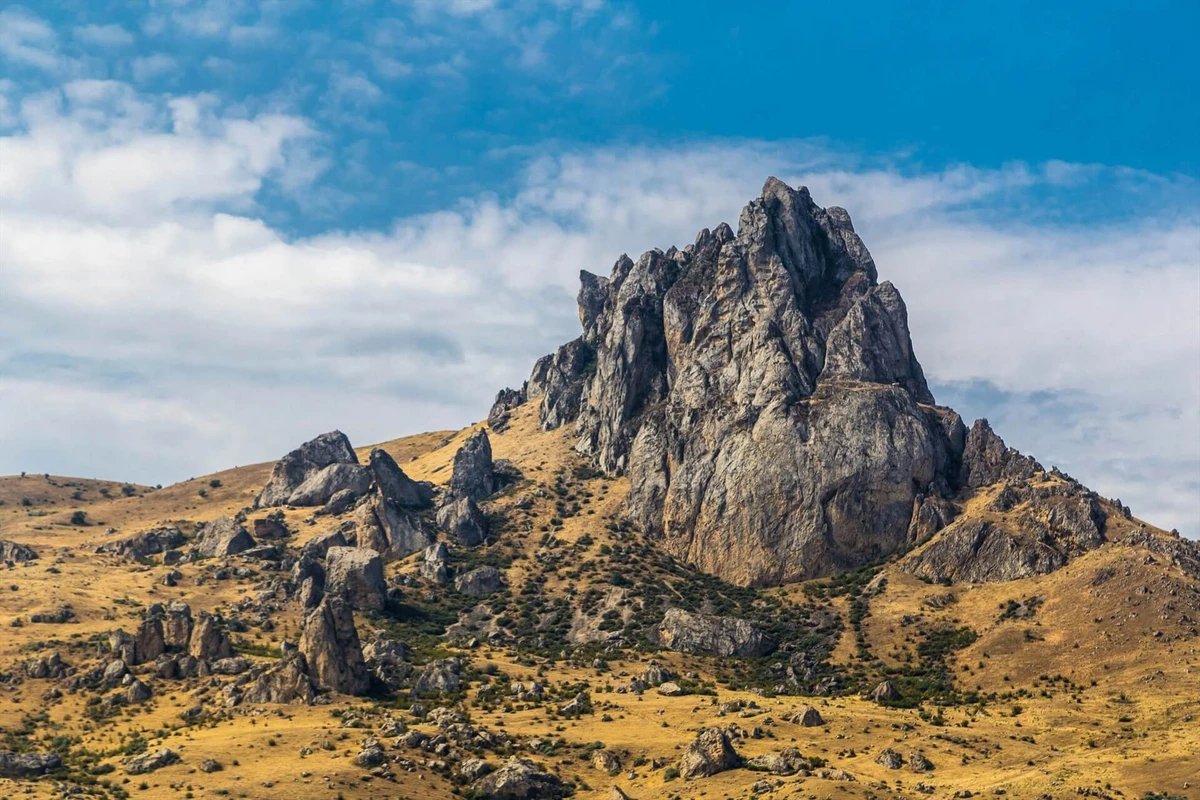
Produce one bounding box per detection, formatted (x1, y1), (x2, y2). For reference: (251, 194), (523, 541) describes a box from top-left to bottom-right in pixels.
(0, 179), (1200, 798)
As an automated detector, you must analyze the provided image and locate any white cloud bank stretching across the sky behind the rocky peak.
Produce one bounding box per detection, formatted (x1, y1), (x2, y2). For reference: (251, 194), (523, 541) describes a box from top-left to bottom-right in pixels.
(0, 9), (1200, 535)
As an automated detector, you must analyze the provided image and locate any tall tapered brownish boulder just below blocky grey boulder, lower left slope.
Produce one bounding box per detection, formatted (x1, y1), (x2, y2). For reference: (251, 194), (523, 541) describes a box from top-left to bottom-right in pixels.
(300, 595), (371, 694)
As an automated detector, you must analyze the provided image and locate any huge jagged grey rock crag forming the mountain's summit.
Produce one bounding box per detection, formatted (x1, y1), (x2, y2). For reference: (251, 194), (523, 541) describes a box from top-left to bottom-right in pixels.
(509, 179), (966, 584)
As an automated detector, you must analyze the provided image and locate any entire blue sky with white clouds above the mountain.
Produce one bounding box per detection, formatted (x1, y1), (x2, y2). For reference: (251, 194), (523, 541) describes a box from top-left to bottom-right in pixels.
(0, 0), (1200, 535)
